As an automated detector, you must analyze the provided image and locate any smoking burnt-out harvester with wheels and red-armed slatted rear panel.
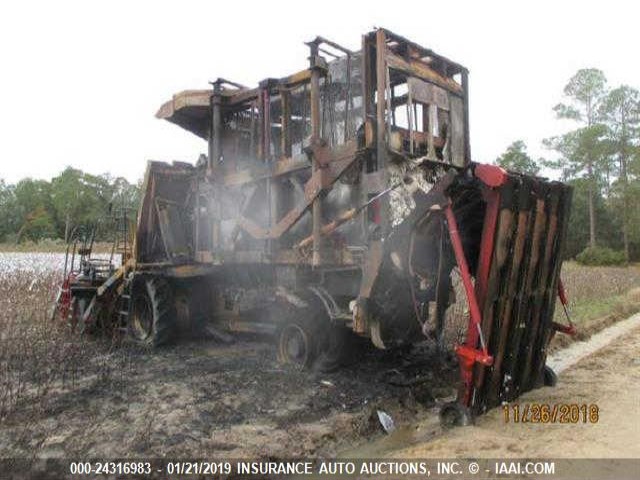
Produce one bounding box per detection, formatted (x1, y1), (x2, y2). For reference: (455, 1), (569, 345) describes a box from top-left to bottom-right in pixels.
(107, 29), (570, 420)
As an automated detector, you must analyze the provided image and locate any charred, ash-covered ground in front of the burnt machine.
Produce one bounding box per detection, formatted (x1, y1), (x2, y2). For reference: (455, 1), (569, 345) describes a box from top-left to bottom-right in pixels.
(0, 339), (455, 458)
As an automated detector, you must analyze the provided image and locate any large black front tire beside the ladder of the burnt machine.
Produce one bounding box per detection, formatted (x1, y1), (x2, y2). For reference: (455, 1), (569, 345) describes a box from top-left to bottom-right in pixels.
(127, 277), (177, 347)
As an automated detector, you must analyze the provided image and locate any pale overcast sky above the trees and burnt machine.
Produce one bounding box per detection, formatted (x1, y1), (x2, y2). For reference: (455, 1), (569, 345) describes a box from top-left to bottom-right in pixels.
(0, 0), (640, 183)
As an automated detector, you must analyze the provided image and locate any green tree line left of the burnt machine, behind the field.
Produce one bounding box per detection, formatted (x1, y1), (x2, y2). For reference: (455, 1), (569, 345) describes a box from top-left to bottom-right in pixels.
(0, 167), (139, 243)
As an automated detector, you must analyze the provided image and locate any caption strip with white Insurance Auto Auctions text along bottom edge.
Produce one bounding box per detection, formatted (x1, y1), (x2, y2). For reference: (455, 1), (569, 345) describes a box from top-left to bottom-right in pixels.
(0, 458), (640, 480)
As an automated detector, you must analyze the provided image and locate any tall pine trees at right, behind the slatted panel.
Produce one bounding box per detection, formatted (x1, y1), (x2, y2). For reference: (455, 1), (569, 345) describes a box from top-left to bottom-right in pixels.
(496, 68), (640, 262)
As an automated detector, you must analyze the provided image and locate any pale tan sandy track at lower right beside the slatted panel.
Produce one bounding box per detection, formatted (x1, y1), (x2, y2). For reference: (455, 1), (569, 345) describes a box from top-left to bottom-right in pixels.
(351, 316), (640, 458)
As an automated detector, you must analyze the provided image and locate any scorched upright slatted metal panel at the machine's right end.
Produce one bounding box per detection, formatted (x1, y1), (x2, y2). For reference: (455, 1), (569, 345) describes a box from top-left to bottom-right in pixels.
(462, 173), (571, 413)
